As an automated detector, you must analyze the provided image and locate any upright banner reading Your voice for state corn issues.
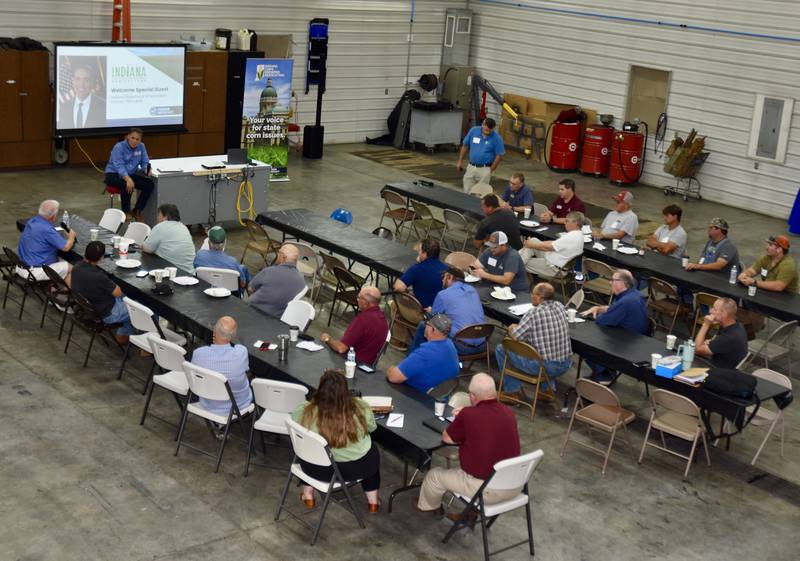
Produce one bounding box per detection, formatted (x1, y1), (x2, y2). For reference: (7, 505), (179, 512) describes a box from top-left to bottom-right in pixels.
(242, 58), (293, 179)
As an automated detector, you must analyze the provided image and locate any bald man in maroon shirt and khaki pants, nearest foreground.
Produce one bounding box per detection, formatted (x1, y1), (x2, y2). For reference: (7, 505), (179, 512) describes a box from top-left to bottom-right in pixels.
(415, 373), (522, 513)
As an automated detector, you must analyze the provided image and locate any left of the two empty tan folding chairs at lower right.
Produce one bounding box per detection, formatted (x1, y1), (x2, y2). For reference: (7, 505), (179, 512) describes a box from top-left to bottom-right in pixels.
(561, 378), (636, 475)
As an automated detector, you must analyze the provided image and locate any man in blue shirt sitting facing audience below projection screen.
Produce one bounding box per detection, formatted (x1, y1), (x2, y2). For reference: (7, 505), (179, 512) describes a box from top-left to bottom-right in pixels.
(105, 128), (153, 222)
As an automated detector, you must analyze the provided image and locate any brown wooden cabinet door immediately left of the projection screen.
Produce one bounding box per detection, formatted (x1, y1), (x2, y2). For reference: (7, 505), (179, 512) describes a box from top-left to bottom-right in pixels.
(20, 51), (53, 142)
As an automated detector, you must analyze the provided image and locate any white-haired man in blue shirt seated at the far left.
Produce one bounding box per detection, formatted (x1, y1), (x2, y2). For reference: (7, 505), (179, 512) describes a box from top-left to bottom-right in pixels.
(17, 200), (75, 281)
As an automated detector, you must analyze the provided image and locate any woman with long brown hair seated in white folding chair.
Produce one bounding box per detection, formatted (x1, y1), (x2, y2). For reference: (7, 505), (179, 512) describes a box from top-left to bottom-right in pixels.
(292, 369), (381, 513)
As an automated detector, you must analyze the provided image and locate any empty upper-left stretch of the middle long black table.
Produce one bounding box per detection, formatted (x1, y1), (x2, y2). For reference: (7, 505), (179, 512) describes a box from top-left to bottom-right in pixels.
(256, 208), (417, 278)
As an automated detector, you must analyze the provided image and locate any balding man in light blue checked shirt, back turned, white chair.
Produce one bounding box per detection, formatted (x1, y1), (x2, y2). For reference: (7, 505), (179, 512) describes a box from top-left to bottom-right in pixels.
(192, 316), (253, 417)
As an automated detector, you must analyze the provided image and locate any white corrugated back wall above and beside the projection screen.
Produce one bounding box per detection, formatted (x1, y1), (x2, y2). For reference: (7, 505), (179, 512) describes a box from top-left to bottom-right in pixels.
(0, 0), (466, 142)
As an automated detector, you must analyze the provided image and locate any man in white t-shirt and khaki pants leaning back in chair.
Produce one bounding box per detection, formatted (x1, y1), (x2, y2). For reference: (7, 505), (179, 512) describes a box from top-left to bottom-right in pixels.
(519, 212), (584, 279)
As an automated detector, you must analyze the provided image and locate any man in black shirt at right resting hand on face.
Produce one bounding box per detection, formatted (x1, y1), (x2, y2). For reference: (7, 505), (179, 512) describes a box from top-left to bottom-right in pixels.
(694, 298), (747, 368)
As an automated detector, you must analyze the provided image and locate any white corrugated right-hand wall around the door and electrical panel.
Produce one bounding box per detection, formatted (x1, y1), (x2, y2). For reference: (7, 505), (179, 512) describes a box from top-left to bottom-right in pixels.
(469, 0), (800, 216)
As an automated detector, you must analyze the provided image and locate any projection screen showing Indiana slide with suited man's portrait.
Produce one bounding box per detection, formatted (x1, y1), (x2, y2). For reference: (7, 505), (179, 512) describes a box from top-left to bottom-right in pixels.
(55, 44), (186, 136)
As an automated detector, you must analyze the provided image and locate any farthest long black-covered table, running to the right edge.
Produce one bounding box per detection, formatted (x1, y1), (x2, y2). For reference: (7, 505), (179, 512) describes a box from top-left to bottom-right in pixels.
(384, 182), (800, 321)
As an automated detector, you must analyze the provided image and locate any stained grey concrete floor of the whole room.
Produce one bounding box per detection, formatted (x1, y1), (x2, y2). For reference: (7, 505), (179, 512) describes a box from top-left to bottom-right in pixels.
(0, 145), (800, 561)
